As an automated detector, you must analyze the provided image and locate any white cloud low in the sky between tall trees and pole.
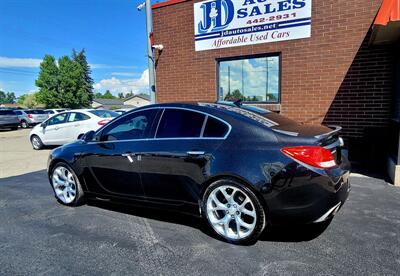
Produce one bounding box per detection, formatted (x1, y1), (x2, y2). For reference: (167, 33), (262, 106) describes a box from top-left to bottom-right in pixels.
(94, 69), (149, 94)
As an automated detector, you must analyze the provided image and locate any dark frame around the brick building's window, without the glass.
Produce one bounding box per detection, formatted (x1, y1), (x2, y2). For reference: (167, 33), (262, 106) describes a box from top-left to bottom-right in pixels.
(215, 52), (282, 104)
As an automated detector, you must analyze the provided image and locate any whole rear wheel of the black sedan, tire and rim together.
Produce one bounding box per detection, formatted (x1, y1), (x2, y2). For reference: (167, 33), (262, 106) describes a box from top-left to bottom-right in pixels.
(201, 179), (266, 244)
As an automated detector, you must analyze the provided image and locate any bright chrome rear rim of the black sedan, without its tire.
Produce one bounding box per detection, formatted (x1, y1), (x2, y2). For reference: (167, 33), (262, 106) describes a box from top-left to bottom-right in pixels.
(206, 185), (257, 240)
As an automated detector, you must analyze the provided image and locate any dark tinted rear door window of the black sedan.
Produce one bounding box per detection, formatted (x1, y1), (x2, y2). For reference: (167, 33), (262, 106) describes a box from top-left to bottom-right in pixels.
(157, 109), (205, 138)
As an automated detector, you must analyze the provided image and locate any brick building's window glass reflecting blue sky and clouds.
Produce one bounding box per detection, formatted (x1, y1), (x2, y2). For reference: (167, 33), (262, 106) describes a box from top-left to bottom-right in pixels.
(218, 55), (280, 103)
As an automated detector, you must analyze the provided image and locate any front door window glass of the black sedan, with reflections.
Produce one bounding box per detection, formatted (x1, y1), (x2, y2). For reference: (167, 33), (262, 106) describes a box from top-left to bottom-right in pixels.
(100, 109), (158, 141)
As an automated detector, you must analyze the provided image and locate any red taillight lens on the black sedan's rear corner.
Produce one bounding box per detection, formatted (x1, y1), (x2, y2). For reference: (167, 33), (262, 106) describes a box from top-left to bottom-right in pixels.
(281, 146), (336, 169)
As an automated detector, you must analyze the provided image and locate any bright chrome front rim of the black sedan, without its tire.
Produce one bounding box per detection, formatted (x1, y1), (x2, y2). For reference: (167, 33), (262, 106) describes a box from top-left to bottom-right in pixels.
(52, 166), (76, 204)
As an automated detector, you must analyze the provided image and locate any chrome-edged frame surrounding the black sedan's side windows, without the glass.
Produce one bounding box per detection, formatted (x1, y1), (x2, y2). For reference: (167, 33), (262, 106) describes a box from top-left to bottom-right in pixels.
(89, 106), (232, 144)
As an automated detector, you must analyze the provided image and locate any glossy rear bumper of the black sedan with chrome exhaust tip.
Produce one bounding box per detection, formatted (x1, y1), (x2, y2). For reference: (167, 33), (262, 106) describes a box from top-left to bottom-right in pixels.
(264, 156), (351, 224)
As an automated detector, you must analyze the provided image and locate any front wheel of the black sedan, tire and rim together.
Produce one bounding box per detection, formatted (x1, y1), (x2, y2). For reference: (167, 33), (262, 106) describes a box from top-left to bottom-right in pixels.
(50, 162), (85, 207)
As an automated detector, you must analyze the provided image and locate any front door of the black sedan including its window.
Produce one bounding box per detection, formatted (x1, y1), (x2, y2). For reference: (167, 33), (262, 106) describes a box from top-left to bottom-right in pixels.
(82, 109), (159, 197)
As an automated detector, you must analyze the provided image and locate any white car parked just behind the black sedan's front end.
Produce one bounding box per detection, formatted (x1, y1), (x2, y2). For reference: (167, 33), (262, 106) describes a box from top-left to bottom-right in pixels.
(29, 109), (119, 150)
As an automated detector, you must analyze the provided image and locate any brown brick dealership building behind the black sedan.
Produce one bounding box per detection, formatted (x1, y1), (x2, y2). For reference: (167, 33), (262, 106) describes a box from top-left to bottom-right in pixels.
(153, 0), (400, 182)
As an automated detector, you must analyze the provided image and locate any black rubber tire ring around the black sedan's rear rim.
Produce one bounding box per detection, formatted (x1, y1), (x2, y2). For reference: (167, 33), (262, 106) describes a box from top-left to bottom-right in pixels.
(201, 179), (267, 245)
